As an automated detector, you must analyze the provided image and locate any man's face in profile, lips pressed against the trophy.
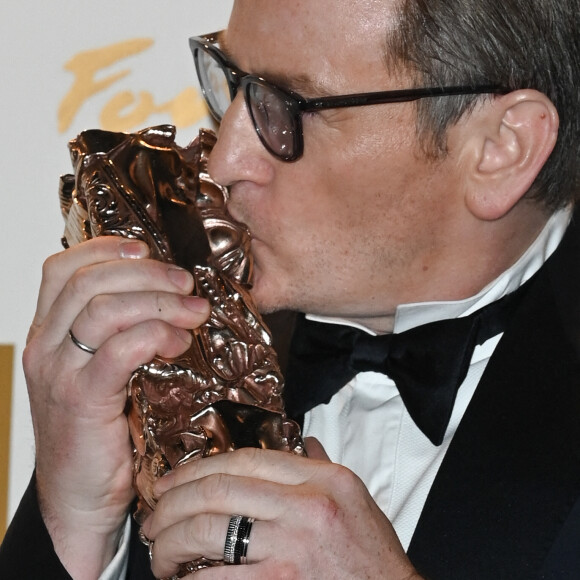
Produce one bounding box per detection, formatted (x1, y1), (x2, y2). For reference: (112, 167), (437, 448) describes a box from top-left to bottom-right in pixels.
(210, 0), (464, 330)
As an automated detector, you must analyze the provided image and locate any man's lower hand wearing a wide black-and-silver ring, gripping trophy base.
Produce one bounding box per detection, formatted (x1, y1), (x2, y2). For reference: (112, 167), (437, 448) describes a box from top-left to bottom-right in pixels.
(143, 440), (420, 580)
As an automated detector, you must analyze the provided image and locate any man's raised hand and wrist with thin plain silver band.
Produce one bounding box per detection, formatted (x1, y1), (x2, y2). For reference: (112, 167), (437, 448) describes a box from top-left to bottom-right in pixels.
(24, 237), (209, 579)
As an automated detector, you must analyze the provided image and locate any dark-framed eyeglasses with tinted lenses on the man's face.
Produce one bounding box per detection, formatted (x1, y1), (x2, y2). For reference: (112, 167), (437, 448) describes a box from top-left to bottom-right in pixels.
(189, 32), (509, 161)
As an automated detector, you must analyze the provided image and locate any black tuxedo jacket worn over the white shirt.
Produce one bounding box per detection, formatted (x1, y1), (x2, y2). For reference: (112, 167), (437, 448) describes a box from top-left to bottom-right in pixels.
(0, 210), (580, 580)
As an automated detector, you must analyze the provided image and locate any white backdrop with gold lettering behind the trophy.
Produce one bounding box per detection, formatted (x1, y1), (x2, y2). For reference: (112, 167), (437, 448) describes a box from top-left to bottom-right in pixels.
(0, 0), (232, 514)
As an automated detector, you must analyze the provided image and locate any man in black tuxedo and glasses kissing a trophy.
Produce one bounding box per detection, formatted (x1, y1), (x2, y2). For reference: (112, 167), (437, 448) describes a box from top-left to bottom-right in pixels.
(2, 0), (580, 579)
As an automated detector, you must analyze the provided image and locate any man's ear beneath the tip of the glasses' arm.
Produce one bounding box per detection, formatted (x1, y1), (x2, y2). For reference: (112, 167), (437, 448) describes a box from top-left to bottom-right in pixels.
(463, 89), (559, 220)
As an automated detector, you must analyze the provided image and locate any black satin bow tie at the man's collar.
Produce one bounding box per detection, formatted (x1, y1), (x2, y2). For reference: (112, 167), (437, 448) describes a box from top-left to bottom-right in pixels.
(285, 283), (529, 445)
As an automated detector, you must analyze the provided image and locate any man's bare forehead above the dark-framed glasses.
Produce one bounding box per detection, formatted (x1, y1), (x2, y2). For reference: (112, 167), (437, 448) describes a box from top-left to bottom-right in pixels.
(224, 0), (396, 88)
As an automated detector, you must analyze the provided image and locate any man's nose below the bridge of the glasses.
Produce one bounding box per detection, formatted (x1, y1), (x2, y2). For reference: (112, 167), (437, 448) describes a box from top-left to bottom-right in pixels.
(208, 93), (276, 187)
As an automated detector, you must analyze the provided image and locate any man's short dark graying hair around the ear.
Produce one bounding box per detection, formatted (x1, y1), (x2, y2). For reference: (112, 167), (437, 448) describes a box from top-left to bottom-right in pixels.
(386, 0), (580, 210)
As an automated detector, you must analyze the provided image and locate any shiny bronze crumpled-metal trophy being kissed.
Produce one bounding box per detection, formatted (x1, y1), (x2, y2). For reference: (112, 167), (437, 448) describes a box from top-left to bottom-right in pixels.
(60, 125), (304, 577)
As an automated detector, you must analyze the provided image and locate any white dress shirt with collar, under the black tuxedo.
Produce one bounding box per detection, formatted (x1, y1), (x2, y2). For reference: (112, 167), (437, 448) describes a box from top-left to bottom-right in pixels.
(99, 210), (571, 580)
